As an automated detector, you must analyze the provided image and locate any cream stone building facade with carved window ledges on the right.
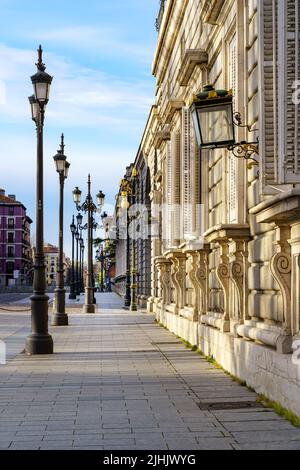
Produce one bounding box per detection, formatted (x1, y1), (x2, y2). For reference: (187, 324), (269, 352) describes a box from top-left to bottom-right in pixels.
(136, 0), (300, 414)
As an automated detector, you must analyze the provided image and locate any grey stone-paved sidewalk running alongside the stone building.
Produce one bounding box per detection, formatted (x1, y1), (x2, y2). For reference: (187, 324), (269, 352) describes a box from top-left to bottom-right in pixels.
(0, 294), (300, 450)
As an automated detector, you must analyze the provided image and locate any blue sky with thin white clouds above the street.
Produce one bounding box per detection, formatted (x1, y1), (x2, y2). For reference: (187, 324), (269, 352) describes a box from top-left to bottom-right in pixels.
(0, 0), (159, 254)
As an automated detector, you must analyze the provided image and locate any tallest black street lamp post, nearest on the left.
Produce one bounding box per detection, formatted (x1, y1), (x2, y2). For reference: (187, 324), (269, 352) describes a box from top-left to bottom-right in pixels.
(25, 46), (53, 355)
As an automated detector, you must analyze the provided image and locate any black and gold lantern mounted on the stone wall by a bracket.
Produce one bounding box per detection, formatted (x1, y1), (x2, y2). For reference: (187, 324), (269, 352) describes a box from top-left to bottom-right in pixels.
(190, 85), (258, 168)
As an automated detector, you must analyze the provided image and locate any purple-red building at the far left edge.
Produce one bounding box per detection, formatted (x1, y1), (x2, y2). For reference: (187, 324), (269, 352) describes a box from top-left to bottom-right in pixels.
(0, 189), (33, 288)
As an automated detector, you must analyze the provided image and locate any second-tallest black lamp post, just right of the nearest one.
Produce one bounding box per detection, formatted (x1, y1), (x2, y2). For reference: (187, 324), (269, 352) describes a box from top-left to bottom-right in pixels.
(51, 134), (70, 326)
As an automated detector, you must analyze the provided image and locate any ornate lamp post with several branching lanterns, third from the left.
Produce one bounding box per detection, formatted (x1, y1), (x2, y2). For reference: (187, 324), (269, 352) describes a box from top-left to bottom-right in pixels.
(73, 175), (105, 313)
